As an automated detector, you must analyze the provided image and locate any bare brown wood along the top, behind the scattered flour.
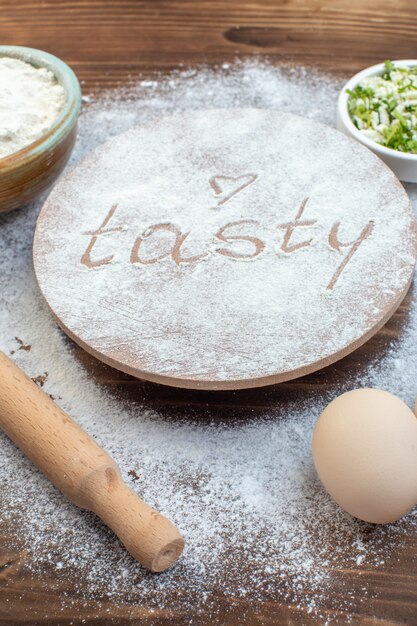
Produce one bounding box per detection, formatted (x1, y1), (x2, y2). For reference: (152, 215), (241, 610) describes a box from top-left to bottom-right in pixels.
(0, 0), (417, 90)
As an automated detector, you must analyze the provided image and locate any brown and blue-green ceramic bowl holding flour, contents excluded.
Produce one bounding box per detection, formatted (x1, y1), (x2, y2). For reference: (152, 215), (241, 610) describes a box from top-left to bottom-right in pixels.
(0, 46), (81, 212)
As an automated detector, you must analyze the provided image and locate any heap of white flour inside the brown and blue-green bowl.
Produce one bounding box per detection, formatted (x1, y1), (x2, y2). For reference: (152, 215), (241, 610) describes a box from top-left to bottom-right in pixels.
(0, 57), (65, 158)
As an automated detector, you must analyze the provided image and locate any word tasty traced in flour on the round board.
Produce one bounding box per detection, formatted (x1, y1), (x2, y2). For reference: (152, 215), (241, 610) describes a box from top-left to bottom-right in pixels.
(81, 187), (374, 290)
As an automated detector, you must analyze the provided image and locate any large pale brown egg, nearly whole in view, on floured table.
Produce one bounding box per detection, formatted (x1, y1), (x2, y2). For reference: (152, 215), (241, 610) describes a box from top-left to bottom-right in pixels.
(313, 389), (417, 524)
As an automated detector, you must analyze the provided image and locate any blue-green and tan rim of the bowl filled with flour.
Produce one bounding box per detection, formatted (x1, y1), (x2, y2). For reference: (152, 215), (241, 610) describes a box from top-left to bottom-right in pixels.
(0, 46), (81, 173)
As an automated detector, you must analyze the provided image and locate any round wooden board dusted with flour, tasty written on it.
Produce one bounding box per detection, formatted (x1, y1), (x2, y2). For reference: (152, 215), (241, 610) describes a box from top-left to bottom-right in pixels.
(34, 109), (416, 389)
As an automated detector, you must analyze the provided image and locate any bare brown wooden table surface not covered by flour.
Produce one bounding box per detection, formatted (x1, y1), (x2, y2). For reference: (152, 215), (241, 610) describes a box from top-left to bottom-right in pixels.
(0, 0), (417, 626)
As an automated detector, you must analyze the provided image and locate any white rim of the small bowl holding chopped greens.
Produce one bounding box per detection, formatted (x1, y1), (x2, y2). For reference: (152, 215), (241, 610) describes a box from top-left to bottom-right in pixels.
(337, 59), (417, 163)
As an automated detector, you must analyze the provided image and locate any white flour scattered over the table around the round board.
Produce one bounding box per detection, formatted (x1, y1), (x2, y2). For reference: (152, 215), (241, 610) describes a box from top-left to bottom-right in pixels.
(0, 64), (417, 624)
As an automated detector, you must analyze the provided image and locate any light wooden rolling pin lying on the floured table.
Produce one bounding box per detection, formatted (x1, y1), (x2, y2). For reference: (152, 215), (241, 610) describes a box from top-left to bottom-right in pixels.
(0, 352), (184, 572)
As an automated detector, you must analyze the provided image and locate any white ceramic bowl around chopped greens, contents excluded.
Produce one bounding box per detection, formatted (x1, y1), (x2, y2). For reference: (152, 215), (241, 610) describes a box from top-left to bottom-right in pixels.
(337, 59), (417, 183)
